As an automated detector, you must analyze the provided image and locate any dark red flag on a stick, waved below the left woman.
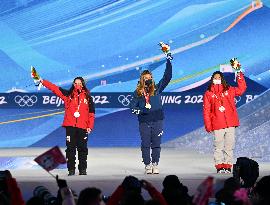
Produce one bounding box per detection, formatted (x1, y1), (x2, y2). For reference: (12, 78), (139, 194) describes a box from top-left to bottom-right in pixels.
(34, 146), (67, 171)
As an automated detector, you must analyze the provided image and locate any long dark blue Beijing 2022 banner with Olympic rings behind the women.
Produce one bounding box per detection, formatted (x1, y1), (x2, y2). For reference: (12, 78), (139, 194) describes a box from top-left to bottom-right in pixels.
(0, 91), (261, 109)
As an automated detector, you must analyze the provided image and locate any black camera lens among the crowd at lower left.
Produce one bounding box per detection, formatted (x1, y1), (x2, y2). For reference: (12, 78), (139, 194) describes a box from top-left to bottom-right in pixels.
(33, 186), (58, 205)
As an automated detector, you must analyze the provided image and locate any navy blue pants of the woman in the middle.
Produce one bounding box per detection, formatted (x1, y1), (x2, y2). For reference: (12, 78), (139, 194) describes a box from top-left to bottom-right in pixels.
(139, 120), (163, 165)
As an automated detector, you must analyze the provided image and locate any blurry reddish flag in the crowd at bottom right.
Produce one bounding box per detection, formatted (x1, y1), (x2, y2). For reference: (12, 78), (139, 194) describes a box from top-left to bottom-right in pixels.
(192, 176), (214, 205)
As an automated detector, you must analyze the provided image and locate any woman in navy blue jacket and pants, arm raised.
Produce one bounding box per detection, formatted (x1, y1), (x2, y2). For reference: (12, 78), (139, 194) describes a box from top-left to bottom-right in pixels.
(130, 59), (172, 174)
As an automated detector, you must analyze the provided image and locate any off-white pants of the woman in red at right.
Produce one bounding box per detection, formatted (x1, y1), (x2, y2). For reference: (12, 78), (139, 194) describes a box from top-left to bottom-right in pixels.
(214, 127), (235, 165)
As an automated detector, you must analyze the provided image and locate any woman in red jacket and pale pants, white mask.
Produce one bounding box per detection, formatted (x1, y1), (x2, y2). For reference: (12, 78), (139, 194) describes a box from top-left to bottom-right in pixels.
(203, 63), (247, 173)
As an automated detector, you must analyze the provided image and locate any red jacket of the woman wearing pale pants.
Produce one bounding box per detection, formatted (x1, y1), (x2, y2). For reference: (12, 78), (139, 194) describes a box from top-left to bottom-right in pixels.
(203, 73), (247, 132)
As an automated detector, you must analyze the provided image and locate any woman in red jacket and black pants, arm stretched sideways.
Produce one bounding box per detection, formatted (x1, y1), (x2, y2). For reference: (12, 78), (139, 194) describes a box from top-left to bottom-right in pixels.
(41, 77), (95, 175)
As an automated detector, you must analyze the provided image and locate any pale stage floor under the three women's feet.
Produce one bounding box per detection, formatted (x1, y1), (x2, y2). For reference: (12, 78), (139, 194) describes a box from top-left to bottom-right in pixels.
(0, 148), (270, 199)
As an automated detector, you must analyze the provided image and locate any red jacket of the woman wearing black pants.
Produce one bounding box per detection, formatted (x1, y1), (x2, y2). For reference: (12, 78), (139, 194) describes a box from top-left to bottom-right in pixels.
(42, 80), (95, 129)
